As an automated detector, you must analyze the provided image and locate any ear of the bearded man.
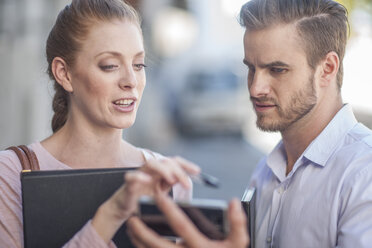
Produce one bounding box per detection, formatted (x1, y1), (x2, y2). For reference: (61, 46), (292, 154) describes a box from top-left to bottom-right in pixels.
(320, 52), (340, 87)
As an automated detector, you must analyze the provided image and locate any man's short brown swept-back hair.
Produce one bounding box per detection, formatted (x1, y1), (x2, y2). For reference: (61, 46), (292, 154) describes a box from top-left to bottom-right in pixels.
(240, 0), (349, 89)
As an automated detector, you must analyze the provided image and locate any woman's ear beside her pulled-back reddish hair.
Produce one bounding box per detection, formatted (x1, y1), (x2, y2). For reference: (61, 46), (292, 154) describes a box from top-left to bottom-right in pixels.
(52, 57), (74, 93)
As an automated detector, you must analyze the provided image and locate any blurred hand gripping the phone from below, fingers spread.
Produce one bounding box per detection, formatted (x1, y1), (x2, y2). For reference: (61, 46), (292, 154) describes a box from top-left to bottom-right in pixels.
(128, 194), (249, 248)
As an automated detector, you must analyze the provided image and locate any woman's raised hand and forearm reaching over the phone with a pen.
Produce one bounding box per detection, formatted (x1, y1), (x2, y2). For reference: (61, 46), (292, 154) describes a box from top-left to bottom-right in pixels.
(92, 157), (200, 243)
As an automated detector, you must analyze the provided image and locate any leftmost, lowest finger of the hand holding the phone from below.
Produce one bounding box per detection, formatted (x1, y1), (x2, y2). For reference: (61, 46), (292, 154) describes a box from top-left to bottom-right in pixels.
(127, 216), (177, 248)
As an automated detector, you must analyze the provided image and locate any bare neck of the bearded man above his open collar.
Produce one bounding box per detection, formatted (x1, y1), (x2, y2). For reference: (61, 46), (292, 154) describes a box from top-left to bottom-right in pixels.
(282, 98), (342, 175)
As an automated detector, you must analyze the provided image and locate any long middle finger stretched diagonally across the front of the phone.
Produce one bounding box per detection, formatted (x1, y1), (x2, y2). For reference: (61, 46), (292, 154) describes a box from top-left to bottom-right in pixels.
(155, 194), (208, 247)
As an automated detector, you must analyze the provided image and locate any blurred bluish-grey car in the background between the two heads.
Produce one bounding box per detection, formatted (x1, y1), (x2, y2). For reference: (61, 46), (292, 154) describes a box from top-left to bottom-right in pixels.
(175, 68), (249, 135)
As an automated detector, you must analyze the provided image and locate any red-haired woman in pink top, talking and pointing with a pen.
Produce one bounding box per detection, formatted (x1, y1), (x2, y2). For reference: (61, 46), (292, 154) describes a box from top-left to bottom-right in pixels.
(0, 0), (199, 247)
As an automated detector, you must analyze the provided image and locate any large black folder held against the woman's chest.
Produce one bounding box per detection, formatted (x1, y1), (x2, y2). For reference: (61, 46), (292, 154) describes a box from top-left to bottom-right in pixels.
(21, 168), (134, 248)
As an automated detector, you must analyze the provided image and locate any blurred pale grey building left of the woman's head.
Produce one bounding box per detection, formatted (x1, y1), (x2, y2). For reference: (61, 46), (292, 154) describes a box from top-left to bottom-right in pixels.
(0, 0), (68, 148)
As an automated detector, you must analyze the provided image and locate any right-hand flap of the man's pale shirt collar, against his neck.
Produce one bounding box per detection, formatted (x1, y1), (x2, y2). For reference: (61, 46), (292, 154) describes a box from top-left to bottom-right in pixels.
(303, 104), (358, 167)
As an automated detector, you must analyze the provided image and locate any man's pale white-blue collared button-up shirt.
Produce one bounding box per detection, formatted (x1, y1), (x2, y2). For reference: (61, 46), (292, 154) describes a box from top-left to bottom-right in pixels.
(250, 104), (372, 248)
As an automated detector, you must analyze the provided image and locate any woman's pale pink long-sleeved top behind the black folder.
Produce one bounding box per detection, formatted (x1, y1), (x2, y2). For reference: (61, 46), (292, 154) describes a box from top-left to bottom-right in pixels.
(0, 142), (192, 248)
